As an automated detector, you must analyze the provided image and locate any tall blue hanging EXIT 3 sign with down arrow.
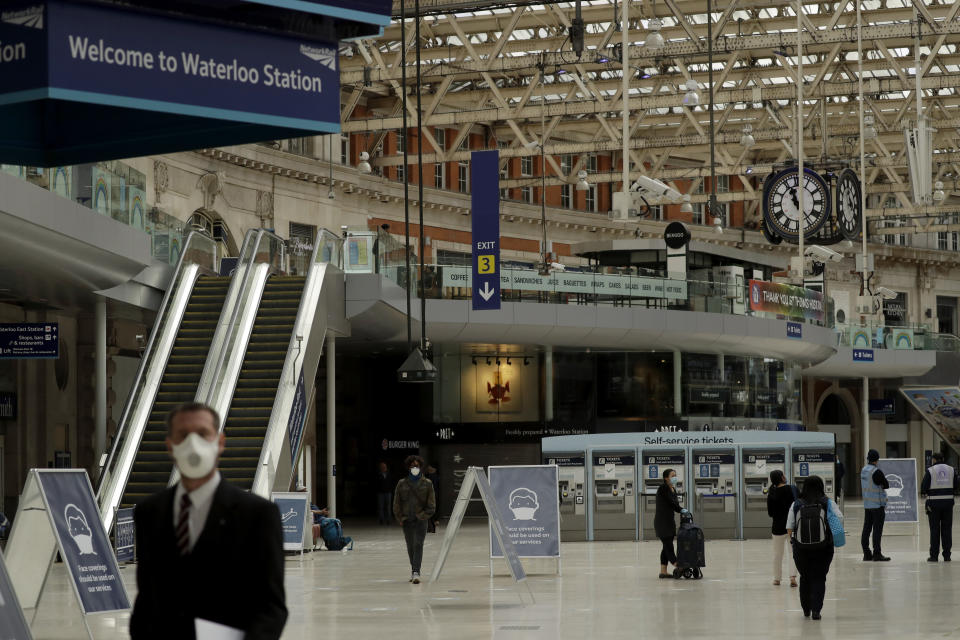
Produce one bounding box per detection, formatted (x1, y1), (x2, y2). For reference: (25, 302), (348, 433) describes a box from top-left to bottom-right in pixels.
(470, 150), (500, 311)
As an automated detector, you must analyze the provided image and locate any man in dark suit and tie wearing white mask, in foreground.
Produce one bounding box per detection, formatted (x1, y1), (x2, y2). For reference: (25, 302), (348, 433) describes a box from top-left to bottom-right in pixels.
(130, 403), (287, 640)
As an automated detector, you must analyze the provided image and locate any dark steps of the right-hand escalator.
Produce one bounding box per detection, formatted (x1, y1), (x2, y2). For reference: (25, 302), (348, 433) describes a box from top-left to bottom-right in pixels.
(220, 276), (306, 490)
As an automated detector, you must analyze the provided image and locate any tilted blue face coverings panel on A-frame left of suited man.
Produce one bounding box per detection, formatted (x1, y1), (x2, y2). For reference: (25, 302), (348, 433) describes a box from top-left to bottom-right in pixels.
(33, 469), (130, 614)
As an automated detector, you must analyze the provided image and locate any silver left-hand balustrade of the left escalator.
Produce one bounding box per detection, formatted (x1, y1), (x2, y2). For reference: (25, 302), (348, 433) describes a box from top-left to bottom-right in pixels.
(97, 231), (217, 526)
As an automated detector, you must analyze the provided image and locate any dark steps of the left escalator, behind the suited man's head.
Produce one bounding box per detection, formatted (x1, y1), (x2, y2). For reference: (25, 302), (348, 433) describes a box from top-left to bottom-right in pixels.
(120, 276), (230, 507)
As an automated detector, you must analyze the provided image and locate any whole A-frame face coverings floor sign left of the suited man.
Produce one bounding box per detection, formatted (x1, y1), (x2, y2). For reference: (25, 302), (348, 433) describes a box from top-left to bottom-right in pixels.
(6, 469), (130, 638)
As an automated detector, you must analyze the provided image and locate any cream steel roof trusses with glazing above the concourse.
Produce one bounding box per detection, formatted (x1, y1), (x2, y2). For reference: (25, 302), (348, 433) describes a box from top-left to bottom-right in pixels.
(340, 0), (960, 233)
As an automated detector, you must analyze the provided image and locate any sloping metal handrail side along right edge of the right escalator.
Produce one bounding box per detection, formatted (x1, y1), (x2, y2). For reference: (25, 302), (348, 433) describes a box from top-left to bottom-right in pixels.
(250, 229), (343, 497)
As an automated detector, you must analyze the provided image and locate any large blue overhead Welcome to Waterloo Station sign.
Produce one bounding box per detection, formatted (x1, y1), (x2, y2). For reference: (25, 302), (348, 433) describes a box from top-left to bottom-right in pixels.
(0, 0), (348, 166)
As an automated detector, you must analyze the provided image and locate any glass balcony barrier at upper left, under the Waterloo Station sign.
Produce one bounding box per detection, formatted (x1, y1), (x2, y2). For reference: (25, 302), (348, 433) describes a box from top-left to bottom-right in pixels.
(0, 160), (189, 264)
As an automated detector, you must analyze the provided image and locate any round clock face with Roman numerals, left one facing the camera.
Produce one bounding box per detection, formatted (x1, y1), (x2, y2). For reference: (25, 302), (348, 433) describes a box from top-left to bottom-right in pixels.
(763, 167), (830, 241)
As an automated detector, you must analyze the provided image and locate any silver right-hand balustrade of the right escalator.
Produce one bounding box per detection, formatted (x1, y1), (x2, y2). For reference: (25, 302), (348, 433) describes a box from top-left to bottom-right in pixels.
(250, 229), (343, 497)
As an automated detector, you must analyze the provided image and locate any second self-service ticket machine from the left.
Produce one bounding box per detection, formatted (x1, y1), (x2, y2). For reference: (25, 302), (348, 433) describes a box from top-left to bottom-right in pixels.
(593, 452), (637, 540)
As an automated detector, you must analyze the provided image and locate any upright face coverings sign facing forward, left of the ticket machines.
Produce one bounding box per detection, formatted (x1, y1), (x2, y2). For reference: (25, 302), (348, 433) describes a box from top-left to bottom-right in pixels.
(489, 464), (560, 558)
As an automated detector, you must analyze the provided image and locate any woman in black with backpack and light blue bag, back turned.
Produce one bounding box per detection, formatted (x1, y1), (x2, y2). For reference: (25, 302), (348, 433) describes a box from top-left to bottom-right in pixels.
(787, 476), (843, 620)
